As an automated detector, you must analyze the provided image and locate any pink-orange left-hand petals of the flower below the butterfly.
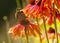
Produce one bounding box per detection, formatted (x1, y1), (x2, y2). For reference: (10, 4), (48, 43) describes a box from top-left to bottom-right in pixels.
(8, 24), (24, 39)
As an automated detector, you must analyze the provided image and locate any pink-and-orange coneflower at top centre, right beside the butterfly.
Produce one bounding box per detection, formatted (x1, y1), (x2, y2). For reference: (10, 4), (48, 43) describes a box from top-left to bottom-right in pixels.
(22, 0), (41, 19)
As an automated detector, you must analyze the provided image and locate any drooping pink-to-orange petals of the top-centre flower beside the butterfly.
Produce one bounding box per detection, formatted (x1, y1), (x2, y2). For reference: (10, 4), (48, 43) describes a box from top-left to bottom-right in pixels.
(23, 5), (41, 18)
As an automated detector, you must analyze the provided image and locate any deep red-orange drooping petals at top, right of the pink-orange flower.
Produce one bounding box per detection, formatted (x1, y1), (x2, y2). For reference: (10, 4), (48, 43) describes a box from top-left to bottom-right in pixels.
(40, 0), (53, 16)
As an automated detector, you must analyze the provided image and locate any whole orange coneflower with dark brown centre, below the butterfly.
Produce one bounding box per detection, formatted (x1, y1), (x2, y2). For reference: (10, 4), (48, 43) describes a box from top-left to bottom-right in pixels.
(8, 18), (41, 39)
